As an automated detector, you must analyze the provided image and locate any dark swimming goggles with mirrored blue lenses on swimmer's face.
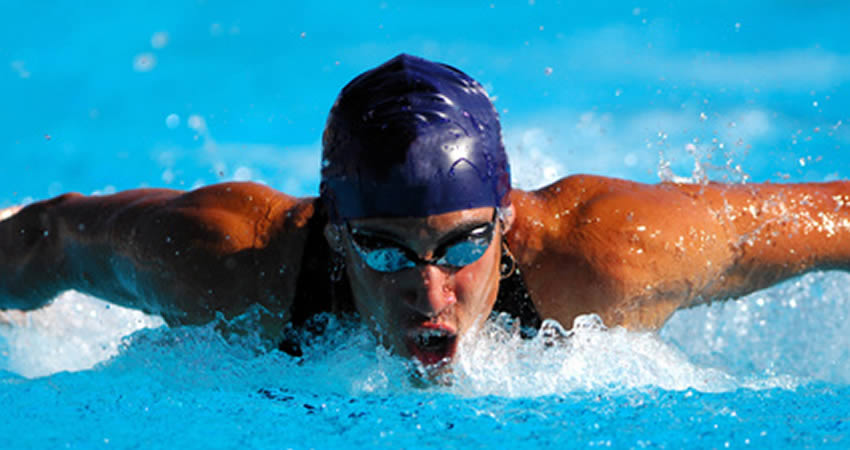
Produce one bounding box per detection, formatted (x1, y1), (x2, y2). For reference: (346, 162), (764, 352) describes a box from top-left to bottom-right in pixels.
(346, 210), (496, 272)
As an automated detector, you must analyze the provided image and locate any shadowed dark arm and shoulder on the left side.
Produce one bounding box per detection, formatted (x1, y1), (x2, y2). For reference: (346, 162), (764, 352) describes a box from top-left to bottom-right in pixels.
(0, 183), (313, 323)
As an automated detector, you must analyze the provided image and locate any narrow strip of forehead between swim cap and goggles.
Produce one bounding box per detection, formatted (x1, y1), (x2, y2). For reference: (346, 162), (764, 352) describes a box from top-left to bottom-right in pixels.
(349, 207), (493, 238)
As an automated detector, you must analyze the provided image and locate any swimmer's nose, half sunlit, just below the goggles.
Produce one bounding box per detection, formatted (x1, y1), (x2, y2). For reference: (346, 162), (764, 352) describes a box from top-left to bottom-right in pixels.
(406, 264), (457, 318)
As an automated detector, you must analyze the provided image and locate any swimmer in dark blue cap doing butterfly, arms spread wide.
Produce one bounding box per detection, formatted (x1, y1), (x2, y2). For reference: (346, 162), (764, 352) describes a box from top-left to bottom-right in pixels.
(0, 55), (850, 366)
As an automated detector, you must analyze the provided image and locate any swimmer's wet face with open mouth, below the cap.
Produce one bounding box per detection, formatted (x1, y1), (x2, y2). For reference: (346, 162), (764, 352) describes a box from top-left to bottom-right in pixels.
(330, 207), (503, 365)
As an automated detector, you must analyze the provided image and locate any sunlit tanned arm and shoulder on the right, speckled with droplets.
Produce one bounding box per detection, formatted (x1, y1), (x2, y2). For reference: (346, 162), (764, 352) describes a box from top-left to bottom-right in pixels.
(508, 176), (850, 328)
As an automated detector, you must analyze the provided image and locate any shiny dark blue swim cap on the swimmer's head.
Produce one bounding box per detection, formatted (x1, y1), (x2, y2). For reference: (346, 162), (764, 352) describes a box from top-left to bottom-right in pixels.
(320, 54), (510, 222)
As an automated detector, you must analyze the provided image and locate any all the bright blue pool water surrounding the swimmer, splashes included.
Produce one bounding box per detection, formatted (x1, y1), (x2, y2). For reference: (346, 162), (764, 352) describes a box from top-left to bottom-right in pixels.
(0, 0), (850, 448)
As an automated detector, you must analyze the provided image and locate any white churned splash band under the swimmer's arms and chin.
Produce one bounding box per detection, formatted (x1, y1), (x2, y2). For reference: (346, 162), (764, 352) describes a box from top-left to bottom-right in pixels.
(0, 273), (850, 397)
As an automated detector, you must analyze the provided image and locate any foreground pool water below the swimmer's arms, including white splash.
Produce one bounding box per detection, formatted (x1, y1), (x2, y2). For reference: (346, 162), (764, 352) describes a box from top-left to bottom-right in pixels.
(0, 274), (850, 448)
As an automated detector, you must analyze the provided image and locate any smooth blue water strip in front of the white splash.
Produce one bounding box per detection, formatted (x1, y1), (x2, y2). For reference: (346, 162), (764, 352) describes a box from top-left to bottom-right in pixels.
(0, 373), (848, 448)
